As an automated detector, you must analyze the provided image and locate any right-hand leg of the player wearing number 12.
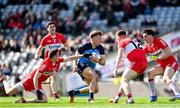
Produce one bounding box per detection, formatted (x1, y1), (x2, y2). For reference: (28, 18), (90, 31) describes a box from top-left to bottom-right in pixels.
(121, 68), (138, 103)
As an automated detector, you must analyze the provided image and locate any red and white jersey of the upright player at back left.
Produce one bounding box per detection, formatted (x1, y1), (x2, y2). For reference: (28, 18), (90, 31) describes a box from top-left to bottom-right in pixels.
(40, 33), (66, 58)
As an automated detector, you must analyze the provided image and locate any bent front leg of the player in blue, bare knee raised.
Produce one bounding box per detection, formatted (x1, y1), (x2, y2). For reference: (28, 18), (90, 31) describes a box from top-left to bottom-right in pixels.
(82, 67), (99, 101)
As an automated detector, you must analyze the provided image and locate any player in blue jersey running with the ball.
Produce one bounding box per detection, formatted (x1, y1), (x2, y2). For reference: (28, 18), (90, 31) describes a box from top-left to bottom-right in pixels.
(68, 30), (106, 103)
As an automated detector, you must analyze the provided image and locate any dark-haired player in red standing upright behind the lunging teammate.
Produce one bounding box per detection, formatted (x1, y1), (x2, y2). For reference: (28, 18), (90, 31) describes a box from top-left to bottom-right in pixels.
(34, 21), (72, 99)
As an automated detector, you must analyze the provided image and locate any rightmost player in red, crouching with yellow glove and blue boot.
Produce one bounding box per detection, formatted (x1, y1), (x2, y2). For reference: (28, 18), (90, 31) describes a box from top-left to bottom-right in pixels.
(143, 29), (180, 102)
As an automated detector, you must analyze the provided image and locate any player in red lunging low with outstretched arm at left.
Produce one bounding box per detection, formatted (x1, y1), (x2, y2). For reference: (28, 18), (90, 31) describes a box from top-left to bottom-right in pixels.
(3, 50), (87, 103)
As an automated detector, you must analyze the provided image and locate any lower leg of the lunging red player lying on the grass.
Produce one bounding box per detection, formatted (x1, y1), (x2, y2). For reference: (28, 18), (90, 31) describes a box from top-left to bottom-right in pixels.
(23, 89), (47, 103)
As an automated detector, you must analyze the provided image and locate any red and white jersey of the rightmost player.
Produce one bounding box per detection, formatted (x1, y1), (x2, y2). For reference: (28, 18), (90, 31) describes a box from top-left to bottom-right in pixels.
(144, 38), (168, 57)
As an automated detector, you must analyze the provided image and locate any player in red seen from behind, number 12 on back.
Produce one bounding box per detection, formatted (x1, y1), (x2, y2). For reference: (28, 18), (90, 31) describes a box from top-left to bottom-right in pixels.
(110, 30), (148, 104)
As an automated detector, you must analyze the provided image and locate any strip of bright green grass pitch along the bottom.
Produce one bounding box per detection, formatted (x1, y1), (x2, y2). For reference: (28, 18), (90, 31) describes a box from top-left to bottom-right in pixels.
(0, 97), (180, 108)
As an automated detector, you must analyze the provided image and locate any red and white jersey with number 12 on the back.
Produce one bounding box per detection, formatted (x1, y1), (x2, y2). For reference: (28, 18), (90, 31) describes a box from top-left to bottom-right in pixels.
(119, 38), (146, 62)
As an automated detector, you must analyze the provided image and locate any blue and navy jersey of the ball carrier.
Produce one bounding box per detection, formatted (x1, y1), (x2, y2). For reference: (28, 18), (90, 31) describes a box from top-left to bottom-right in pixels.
(78, 42), (105, 69)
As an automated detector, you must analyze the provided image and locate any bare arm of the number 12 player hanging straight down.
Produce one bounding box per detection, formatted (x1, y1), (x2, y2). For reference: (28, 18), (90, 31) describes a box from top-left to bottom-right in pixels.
(114, 48), (123, 76)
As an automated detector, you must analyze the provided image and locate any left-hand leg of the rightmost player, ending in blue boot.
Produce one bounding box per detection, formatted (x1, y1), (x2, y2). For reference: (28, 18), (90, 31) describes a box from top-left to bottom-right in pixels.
(148, 65), (164, 102)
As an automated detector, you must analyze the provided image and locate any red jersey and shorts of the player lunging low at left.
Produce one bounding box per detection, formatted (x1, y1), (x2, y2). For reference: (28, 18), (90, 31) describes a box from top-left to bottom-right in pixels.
(22, 57), (64, 91)
